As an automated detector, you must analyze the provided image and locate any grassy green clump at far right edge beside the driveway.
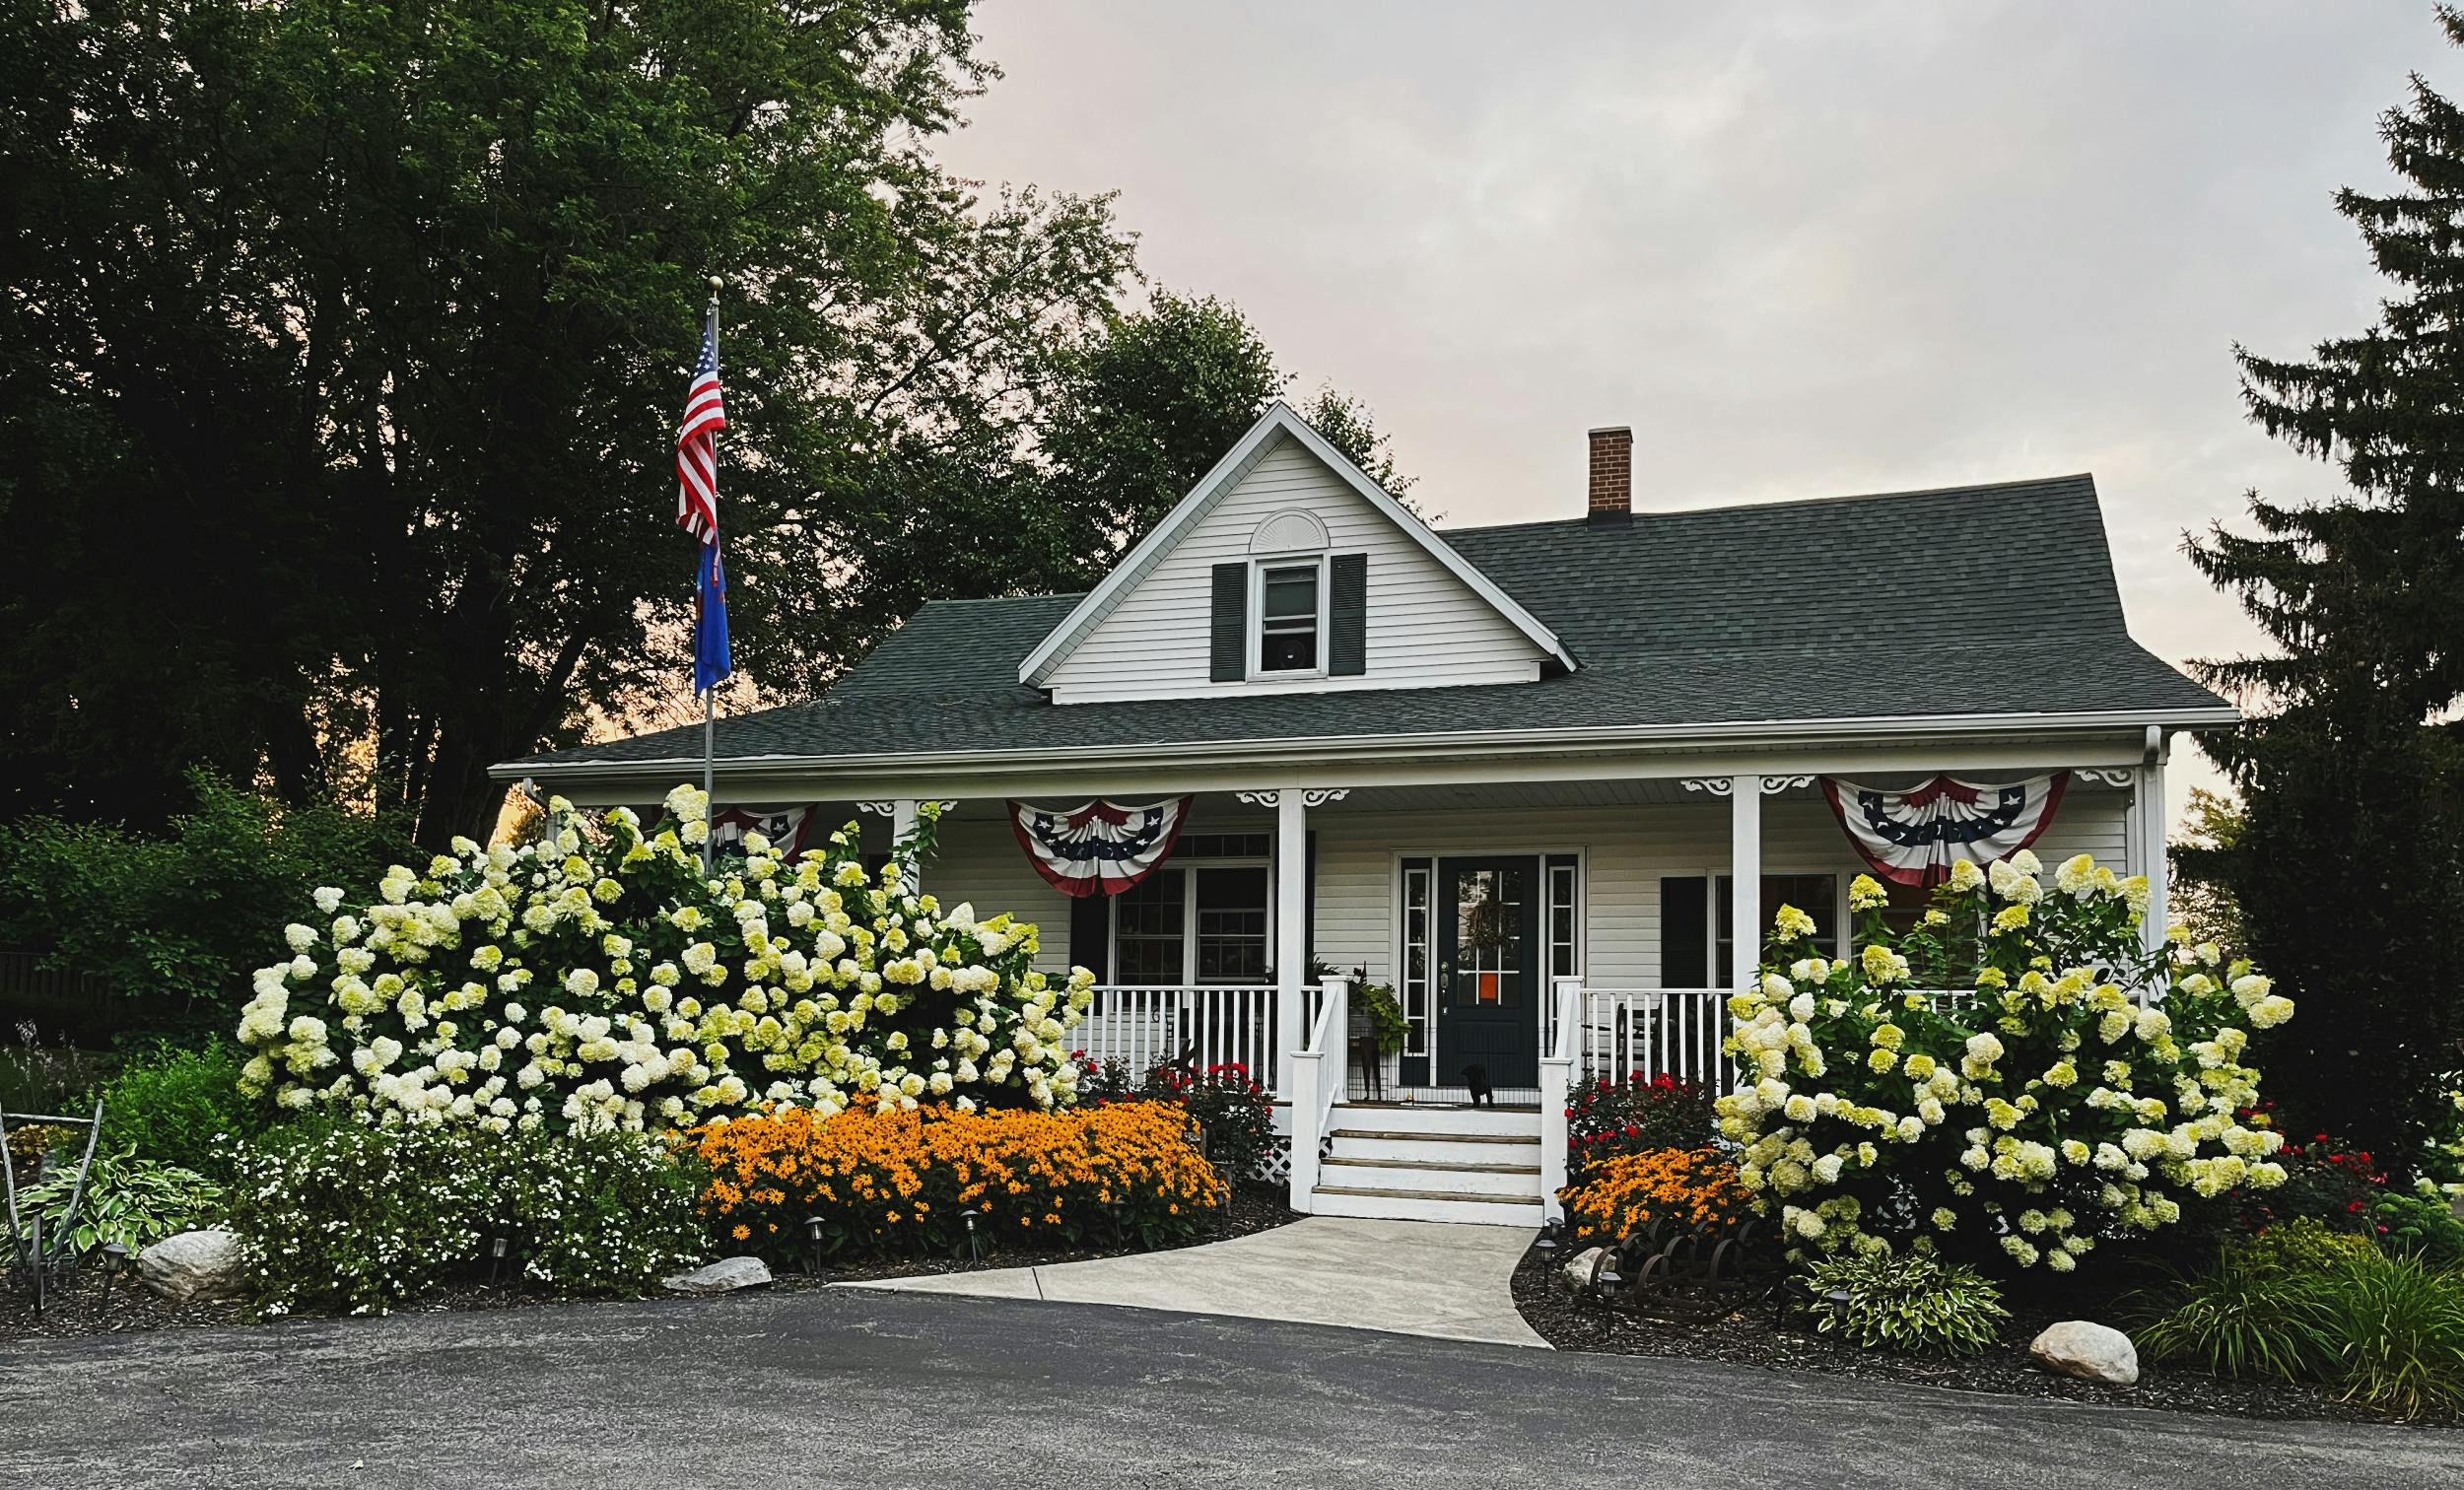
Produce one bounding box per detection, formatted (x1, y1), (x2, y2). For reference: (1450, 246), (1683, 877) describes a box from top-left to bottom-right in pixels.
(2329, 1256), (2464, 1419)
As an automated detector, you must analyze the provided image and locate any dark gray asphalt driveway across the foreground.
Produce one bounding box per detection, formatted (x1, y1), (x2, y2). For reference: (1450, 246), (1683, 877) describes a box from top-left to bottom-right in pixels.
(0, 1288), (2464, 1490)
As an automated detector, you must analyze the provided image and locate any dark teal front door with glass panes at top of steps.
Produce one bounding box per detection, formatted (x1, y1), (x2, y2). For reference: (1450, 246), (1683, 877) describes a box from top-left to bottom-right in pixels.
(1432, 857), (1540, 1086)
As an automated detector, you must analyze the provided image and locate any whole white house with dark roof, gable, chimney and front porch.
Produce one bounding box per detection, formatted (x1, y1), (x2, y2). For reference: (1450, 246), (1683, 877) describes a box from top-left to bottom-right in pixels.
(496, 406), (2235, 1224)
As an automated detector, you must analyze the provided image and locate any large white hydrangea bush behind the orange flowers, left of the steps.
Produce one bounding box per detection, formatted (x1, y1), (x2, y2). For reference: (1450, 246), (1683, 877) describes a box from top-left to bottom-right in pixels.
(240, 785), (1094, 1130)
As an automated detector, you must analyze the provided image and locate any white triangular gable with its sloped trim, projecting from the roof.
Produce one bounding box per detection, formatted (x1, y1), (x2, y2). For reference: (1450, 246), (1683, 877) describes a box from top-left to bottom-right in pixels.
(1023, 416), (1562, 705)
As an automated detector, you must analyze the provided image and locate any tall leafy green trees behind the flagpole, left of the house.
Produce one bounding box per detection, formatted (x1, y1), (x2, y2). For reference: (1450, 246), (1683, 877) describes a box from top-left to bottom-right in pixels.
(0, 0), (1400, 843)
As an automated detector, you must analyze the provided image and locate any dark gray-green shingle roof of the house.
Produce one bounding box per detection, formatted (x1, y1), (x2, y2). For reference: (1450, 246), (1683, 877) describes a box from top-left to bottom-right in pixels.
(500, 475), (2223, 766)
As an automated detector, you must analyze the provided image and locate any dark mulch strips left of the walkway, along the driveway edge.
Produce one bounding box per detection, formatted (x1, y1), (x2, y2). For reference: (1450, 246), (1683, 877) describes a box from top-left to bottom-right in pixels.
(0, 1185), (1301, 1345)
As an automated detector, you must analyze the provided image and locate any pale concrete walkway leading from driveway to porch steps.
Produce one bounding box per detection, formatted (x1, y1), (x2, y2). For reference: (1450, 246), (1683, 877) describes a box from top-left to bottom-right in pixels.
(841, 1217), (1547, 1350)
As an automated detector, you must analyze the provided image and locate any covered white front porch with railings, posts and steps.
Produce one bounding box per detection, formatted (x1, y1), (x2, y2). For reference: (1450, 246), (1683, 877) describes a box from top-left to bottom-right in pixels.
(641, 739), (2163, 1222)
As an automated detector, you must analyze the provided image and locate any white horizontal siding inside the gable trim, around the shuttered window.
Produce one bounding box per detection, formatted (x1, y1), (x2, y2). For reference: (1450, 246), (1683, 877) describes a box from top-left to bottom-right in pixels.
(1045, 439), (1542, 705)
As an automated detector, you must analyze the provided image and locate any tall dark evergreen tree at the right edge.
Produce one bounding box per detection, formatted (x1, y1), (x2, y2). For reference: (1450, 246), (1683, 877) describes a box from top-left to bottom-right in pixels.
(2191, 7), (2464, 1173)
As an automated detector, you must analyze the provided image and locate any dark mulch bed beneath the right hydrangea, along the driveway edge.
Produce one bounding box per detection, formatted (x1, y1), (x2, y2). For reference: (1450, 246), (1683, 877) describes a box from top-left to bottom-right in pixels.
(1513, 1249), (2385, 1424)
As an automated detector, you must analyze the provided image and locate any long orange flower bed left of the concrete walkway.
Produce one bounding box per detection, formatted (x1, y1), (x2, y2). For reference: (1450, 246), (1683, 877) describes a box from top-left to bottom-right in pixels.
(683, 1101), (1230, 1261)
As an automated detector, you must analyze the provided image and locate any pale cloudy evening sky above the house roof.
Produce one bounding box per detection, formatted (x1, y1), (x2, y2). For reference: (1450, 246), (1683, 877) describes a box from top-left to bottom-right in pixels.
(944, 0), (2464, 803)
